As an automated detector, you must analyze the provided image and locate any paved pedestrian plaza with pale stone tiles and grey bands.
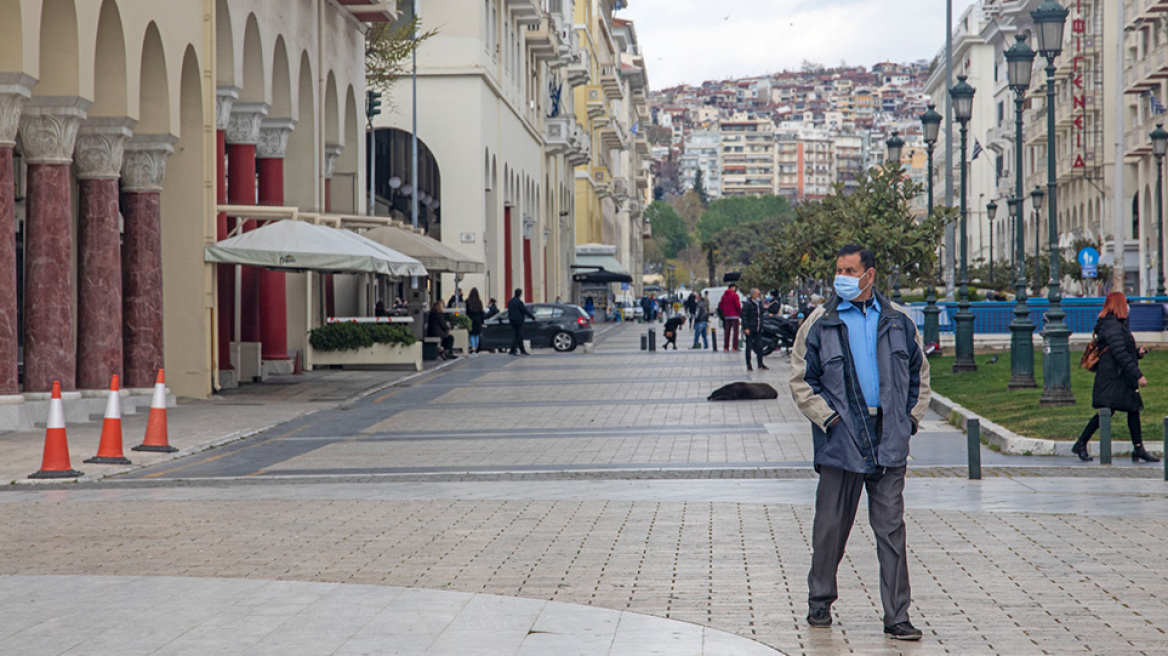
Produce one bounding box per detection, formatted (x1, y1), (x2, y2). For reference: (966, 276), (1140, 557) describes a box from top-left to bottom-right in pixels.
(0, 324), (1168, 655)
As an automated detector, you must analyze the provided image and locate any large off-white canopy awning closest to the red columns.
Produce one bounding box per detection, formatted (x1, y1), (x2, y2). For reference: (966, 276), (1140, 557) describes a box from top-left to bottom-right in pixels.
(204, 219), (426, 278)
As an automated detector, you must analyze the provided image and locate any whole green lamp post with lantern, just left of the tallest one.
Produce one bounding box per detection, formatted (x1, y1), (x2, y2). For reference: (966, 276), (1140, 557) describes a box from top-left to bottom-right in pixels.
(1006, 34), (1042, 390)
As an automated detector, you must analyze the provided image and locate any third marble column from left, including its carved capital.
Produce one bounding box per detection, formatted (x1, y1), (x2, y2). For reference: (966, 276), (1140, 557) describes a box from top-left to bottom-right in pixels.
(74, 118), (134, 390)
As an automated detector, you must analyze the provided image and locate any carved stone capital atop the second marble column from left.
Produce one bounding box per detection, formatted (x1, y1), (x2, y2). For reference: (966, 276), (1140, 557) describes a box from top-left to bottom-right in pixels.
(20, 96), (90, 165)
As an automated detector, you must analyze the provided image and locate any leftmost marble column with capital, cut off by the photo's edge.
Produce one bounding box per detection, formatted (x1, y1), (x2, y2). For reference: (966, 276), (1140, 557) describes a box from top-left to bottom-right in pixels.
(0, 79), (33, 392)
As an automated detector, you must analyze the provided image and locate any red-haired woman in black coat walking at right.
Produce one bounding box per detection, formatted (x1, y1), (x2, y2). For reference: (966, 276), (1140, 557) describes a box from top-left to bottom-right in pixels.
(1071, 292), (1160, 462)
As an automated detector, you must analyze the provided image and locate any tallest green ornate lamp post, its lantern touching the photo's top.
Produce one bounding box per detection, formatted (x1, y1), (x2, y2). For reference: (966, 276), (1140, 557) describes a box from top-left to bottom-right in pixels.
(1030, 0), (1075, 406)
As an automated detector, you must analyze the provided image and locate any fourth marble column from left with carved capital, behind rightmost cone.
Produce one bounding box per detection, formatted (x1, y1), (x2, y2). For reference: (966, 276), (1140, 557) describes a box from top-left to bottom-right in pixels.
(121, 134), (176, 390)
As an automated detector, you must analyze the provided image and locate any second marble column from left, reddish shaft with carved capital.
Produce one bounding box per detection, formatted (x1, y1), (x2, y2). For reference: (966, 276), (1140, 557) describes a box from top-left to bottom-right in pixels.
(20, 97), (90, 392)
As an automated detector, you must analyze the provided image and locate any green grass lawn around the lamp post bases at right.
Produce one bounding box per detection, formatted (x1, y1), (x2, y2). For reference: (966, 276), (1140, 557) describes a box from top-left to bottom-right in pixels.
(929, 348), (1168, 442)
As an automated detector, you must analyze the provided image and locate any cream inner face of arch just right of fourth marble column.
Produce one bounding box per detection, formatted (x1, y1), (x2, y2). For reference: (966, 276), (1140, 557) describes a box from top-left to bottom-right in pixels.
(160, 44), (213, 393)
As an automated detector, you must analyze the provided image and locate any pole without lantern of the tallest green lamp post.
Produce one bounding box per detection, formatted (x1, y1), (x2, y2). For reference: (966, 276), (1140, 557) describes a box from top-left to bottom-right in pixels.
(1038, 57), (1074, 407)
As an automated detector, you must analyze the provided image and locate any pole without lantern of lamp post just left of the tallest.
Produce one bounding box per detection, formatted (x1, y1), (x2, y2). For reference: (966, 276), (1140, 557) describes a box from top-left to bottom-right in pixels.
(1006, 90), (1038, 390)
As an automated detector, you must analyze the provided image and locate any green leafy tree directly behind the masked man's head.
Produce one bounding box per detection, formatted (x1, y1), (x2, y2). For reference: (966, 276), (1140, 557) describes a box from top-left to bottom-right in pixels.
(744, 168), (955, 294)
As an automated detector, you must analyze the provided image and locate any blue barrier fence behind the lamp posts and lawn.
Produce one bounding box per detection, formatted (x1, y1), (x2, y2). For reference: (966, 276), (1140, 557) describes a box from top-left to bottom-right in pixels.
(911, 296), (1168, 335)
